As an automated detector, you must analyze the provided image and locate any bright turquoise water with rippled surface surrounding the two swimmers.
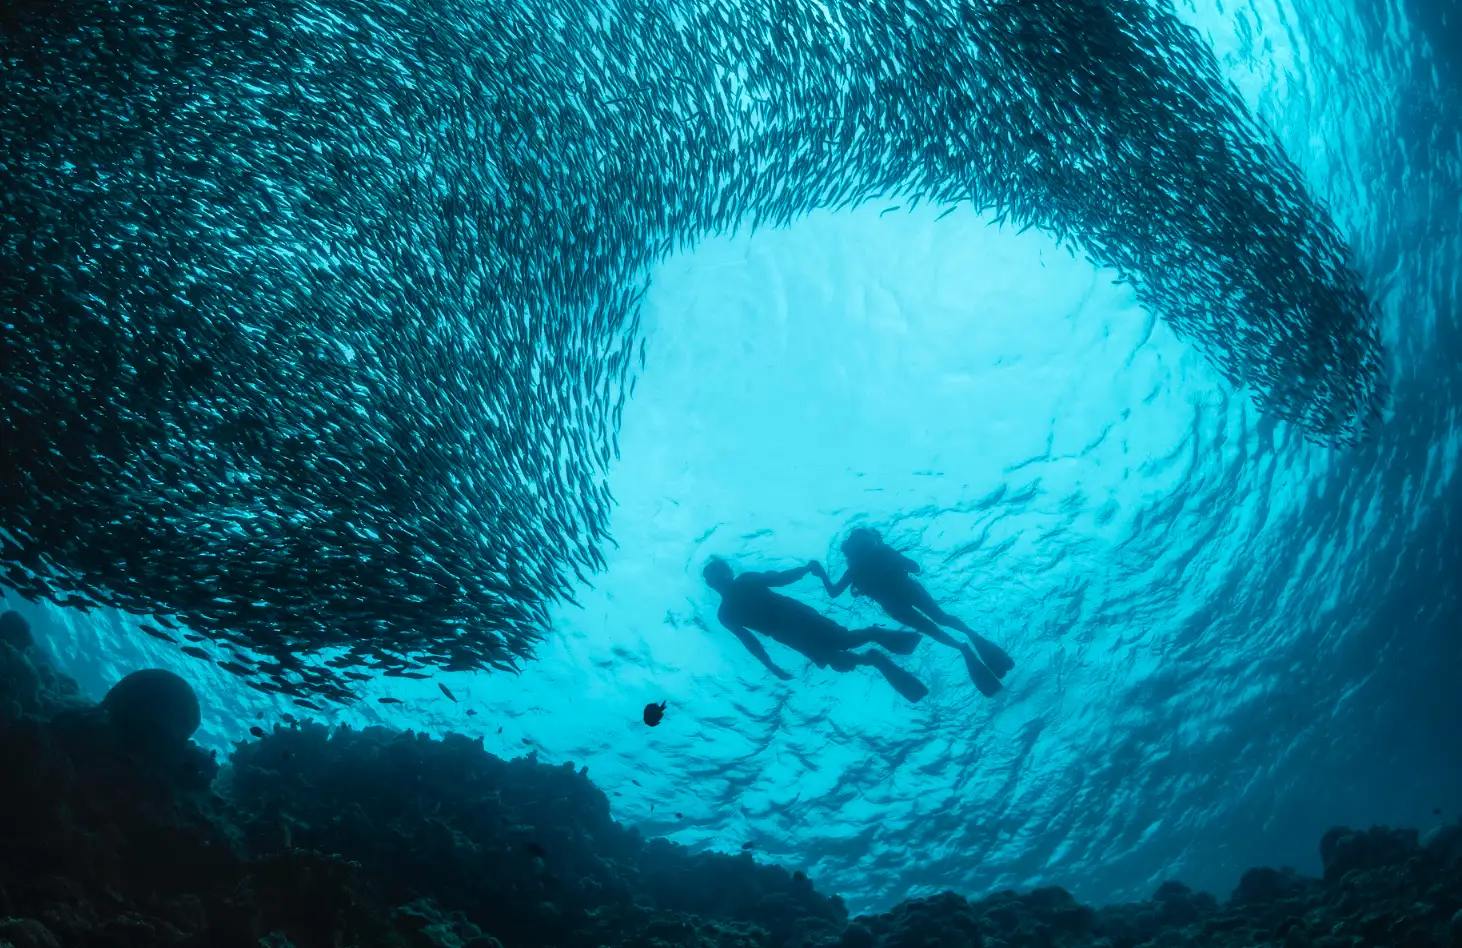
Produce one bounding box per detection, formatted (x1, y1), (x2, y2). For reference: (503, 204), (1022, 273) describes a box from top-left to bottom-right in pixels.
(2, 0), (1462, 911)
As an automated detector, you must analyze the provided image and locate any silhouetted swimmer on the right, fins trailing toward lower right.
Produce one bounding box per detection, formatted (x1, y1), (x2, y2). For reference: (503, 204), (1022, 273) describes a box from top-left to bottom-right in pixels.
(807, 527), (1015, 698)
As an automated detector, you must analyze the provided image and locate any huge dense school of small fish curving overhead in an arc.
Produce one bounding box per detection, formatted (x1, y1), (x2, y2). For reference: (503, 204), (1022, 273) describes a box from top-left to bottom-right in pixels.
(0, 0), (1385, 687)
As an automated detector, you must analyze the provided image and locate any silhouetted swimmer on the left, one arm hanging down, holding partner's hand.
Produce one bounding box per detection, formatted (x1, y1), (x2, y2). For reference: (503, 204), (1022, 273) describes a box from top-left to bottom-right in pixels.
(702, 559), (928, 701)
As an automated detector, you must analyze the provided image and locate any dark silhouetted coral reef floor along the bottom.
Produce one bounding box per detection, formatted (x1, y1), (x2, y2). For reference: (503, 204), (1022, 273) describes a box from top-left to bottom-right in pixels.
(0, 613), (1462, 948)
